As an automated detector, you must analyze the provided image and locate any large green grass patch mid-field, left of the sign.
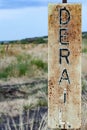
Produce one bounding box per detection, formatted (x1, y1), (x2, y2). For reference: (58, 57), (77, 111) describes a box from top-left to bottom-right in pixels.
(0, 54), (48, 79)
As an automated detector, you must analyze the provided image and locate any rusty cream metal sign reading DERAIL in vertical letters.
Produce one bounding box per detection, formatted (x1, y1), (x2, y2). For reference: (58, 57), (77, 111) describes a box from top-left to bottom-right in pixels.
(48, 3), (82, 129)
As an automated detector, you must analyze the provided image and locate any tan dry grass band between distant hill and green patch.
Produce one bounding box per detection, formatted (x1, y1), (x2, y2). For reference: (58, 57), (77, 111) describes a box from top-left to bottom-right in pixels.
(0, 43), (48, 61)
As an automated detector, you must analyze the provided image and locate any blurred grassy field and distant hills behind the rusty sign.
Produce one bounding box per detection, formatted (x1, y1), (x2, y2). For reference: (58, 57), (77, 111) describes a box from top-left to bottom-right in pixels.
(0, 32), (87, 130)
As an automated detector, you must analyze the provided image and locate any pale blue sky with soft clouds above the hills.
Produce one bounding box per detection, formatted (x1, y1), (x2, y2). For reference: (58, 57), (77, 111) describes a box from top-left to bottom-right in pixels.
(0, 0), (87, 41)
